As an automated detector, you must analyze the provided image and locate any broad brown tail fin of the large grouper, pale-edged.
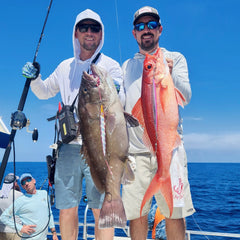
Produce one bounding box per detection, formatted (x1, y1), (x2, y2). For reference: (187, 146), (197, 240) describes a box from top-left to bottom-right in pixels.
(98, 193), (127, 229)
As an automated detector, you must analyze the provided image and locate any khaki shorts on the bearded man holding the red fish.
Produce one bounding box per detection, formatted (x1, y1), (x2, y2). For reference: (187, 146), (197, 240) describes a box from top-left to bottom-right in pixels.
(122, 143), (195, 220)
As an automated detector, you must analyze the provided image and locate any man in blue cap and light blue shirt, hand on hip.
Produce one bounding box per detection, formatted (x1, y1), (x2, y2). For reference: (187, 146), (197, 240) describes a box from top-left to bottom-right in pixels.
(0, 173), (58, 240)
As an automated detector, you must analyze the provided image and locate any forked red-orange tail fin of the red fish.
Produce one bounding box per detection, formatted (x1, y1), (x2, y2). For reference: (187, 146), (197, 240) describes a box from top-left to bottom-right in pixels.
(140, 173), (173, 217)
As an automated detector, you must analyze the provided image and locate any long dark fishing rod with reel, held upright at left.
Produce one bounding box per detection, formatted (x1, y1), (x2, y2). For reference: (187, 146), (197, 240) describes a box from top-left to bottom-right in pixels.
(0, 0), (53, 185)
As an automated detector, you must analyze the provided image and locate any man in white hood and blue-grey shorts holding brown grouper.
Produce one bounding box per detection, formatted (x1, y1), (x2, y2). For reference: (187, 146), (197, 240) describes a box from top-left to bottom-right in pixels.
(20, 9), (124, 240)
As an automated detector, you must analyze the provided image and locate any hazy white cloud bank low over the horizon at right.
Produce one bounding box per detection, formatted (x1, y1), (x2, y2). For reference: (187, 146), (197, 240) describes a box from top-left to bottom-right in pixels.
(184, 133), (240, 151)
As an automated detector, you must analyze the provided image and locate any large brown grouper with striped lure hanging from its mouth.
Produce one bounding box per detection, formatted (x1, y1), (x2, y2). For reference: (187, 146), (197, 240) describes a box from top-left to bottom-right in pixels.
(78, 64), (137, 228)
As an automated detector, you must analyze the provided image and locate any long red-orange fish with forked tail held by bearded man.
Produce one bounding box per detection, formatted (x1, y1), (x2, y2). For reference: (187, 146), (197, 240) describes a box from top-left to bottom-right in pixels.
(132, 48), (185, 216)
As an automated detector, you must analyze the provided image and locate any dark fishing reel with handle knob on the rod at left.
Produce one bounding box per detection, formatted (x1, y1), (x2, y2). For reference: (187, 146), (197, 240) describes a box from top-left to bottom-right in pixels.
(10, 110), (38, 142)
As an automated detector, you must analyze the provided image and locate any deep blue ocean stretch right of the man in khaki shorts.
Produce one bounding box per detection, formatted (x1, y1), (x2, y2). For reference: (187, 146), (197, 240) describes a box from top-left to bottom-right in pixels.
(187, 163), (240, 239)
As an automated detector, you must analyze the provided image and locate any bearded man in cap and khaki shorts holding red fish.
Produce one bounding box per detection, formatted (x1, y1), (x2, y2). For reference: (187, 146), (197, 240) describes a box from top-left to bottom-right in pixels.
(122, 6), (195, 240)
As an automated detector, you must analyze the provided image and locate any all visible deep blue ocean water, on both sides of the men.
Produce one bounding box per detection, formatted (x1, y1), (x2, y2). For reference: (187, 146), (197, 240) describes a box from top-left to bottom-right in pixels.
(2, 162), (240, 240)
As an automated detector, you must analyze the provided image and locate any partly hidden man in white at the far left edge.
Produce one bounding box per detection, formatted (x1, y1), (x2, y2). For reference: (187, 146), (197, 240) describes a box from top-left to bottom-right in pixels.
(0, 173), (23, 240)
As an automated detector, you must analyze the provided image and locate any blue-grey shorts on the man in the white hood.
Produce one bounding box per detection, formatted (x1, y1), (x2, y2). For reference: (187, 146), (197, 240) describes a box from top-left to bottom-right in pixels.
(54, 144), (104, 209)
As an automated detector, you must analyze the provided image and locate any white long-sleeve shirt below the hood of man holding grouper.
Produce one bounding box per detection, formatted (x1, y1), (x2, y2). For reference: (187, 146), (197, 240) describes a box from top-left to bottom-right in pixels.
(31, 53), (124, 105)
